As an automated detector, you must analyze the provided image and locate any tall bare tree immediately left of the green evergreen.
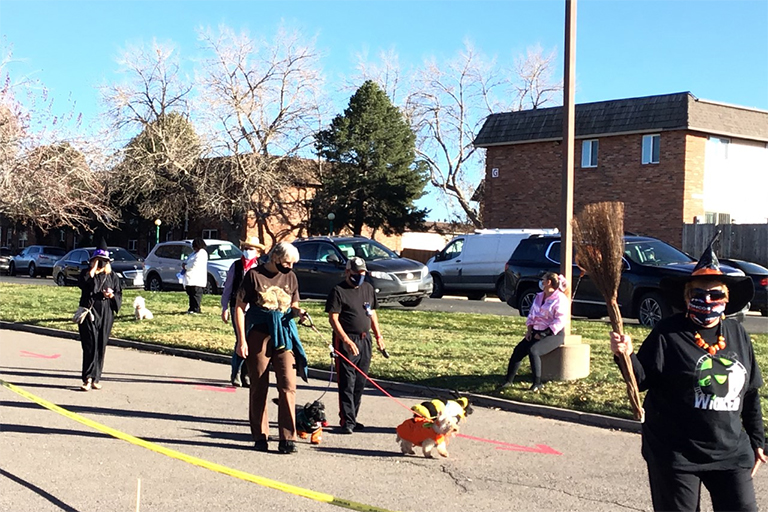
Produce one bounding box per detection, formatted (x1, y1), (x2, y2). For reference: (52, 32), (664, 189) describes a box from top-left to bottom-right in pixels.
(199, 22), (323, 242)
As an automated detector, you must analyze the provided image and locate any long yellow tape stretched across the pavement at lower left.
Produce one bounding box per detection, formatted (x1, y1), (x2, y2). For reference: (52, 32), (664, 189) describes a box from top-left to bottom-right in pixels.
(0, 379), (402, 512)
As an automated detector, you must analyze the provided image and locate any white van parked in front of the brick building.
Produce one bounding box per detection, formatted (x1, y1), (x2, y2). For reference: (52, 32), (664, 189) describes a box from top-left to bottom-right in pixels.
(427, 228), (559, 301)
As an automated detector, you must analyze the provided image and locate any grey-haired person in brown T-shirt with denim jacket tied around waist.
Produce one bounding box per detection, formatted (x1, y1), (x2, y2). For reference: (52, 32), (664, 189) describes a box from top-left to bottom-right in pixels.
(235, 242), (307, 453)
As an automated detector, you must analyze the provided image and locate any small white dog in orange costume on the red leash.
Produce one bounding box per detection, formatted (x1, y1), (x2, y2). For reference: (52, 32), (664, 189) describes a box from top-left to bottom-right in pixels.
(397, 400), (465, 458)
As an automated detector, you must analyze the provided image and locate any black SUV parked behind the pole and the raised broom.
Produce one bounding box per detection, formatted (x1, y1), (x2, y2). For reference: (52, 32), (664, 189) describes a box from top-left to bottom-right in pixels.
(504, 235), (744, 327)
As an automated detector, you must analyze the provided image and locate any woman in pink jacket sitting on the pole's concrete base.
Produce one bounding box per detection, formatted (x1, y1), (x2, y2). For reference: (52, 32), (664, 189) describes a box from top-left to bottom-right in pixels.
(499, 272), (571, 391)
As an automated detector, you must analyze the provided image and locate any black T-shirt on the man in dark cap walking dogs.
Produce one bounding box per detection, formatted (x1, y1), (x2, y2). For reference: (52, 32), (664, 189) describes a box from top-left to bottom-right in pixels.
(325, 279), (379, 335)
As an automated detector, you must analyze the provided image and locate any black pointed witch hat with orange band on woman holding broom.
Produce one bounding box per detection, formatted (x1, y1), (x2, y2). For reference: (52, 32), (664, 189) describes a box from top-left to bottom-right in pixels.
(660, 231), (755, 315)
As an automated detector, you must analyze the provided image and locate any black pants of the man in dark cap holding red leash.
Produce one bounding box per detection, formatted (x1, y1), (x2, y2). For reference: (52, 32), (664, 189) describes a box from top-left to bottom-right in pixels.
(333, 332), (371, 428)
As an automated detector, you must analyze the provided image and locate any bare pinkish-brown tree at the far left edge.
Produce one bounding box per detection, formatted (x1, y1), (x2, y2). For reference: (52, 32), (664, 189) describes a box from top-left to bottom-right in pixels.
(0, 46), (118, 232)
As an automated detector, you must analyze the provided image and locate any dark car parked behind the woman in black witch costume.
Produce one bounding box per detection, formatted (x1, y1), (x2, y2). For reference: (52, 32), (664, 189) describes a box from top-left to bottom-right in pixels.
(53, 247), (144, 288)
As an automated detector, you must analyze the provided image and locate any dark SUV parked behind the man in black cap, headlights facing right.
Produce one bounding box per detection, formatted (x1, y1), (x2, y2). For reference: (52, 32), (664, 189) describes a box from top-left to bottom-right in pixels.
(292, 236), (432, 307)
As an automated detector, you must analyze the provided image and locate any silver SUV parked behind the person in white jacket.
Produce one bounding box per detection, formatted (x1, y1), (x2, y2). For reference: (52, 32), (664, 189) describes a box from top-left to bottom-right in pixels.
(144, 240), (243, 294)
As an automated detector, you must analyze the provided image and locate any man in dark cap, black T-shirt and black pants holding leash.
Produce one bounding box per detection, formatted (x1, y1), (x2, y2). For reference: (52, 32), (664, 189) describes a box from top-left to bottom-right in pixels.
(325, 257), (384, 434)
